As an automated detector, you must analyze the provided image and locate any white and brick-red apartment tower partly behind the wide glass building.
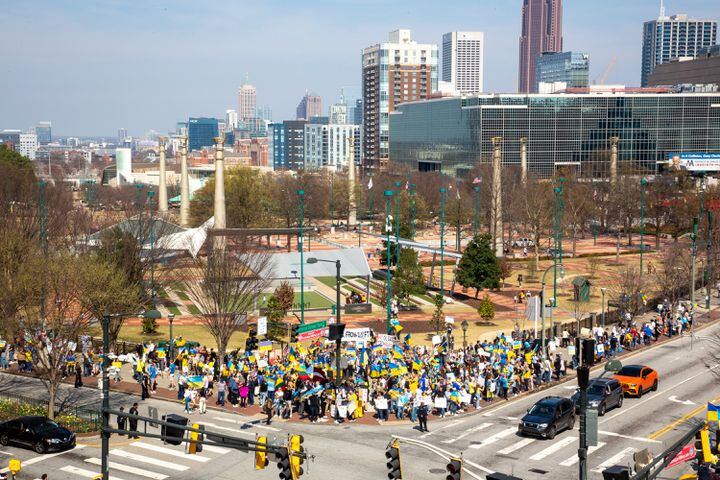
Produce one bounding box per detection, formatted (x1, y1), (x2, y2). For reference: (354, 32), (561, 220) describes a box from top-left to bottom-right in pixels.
(362, 30), (438, 170)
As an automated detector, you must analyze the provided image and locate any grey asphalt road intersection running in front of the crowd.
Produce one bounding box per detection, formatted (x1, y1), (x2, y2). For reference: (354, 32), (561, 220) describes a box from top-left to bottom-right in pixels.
(0, 306), (720, 480)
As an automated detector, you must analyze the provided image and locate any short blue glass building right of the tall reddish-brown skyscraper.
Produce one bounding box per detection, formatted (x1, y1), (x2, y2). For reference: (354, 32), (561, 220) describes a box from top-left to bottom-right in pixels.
(535, 52), (590, 92)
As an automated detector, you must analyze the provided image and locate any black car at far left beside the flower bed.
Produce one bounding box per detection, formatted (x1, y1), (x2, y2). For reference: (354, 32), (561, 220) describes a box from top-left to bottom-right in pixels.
(0, 417), (75, 453)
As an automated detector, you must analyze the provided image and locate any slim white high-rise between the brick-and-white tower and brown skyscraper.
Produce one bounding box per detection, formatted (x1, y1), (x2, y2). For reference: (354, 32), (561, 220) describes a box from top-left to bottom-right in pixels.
(441, 32), (484, 93)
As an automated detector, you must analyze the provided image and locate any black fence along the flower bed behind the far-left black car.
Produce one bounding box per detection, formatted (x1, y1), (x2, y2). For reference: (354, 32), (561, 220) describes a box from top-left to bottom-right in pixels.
(0, 392), (101, 433)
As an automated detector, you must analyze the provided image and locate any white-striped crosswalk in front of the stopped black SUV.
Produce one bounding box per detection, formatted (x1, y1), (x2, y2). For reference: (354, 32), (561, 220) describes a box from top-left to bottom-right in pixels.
(417, 417), (648, 473)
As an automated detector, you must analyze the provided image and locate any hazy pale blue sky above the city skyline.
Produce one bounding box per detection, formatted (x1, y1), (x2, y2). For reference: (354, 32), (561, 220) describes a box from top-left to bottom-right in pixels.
(0, 0), (720, 136)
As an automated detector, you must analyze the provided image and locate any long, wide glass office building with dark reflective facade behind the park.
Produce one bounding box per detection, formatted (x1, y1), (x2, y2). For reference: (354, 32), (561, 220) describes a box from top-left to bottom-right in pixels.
(390, 93), (720, 177)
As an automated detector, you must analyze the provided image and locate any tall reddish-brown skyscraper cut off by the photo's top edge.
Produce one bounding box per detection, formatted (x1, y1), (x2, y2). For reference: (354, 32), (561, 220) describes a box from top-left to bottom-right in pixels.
(518, 0), (562, 93)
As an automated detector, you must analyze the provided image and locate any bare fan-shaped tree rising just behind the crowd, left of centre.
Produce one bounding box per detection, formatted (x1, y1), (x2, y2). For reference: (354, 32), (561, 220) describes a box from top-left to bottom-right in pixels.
(183, 248), (271, 358)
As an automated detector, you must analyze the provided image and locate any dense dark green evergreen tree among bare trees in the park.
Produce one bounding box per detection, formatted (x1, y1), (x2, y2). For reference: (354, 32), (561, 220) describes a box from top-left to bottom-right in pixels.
(457, 234), (500, 298)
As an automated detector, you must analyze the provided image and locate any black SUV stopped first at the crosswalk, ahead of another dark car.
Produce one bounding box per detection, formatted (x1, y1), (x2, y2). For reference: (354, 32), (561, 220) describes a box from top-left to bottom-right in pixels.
(518, 397), (575, 439)
